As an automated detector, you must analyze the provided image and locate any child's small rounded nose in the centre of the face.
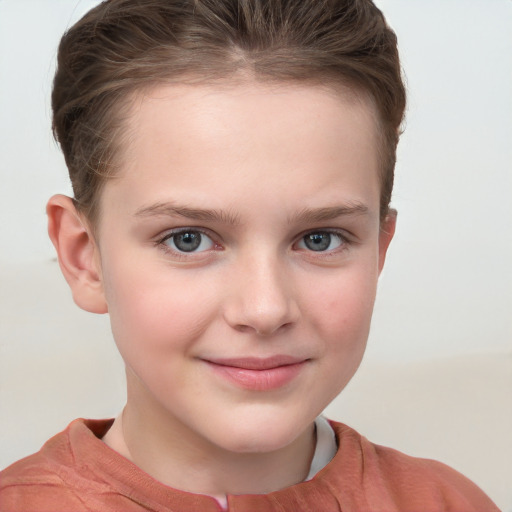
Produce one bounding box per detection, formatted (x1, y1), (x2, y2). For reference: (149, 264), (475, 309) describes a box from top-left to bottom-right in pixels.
(224, 251), (299, 336)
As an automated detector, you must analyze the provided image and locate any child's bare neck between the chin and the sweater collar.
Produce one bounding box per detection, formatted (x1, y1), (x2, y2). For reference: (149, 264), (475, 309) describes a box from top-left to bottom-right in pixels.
(104, 376), (316, 503)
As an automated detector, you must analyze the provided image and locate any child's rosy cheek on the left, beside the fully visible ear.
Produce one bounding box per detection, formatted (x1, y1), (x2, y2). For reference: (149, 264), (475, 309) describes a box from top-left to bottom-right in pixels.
(101, 252), (216, 357)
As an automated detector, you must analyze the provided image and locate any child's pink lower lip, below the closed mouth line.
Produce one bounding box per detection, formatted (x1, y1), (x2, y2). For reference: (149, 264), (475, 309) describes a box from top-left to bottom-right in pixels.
(208, 361), (306, 391)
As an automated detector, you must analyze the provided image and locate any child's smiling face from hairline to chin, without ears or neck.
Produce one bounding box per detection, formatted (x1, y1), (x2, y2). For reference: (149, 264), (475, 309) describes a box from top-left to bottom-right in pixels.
(93, 85), (392, 452)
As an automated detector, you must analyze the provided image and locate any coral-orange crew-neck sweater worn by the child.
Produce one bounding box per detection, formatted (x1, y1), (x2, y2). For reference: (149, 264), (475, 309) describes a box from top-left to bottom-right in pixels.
(0, 420), (499, 512)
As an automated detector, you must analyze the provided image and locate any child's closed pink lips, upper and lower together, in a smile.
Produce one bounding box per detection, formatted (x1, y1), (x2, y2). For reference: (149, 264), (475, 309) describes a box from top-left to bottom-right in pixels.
(204, 355), (309, 391)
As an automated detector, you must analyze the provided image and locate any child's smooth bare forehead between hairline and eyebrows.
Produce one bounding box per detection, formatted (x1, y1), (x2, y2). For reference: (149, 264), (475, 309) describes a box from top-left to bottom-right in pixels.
(101, 83), (379, 220)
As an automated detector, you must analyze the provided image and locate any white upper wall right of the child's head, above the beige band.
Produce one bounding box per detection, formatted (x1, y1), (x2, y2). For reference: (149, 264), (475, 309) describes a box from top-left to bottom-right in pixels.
(371, 0), (512, 359)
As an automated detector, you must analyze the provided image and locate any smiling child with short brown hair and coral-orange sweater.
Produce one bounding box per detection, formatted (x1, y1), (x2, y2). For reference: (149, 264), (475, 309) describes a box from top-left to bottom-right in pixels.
(0, 0), (497, 511)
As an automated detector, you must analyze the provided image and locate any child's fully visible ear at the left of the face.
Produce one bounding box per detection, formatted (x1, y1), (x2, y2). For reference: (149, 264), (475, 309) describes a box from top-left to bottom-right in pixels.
(46, 195), (108, 313)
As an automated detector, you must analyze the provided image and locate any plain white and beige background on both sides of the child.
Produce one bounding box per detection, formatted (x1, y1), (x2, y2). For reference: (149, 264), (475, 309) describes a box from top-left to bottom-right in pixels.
(0, 0), (512, 511)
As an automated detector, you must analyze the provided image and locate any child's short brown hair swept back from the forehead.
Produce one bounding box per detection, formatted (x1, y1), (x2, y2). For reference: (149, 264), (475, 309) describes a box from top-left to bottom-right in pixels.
(52, 0), (405, 223)
